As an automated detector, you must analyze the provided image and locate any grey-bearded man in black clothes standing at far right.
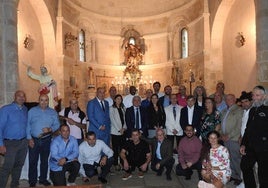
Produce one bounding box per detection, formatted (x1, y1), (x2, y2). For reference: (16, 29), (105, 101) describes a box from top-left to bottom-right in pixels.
(240, 86), (268, 188)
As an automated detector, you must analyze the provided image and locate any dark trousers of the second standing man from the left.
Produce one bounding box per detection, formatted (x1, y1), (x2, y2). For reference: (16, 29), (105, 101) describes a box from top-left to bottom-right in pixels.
(28, 136), (51, 184)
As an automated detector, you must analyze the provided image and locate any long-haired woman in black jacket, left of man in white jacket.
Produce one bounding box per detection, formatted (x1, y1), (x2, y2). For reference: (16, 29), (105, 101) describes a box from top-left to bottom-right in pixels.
(147, 94), (166, 138)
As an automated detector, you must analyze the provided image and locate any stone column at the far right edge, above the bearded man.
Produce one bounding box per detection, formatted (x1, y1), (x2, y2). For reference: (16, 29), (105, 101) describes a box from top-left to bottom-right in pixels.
(255, 0), (268, 82)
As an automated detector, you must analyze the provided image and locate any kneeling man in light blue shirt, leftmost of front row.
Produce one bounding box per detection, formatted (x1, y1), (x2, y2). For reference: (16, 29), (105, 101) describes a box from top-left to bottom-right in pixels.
(49, 124), (80, 186)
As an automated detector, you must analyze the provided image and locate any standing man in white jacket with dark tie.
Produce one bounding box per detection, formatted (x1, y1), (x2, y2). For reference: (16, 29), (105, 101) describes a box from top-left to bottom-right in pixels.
(165, 94), (183, 152)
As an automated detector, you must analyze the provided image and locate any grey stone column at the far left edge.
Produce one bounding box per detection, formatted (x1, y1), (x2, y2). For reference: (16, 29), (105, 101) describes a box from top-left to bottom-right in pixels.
(0, 0), (18, 106)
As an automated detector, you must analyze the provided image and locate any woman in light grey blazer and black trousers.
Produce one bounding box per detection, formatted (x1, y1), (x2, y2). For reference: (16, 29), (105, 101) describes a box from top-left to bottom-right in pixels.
(110, 95), (127, 170)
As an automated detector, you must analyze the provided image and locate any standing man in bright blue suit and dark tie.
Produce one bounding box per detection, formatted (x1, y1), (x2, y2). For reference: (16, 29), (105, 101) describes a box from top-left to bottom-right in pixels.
(87, 87), (111, 146)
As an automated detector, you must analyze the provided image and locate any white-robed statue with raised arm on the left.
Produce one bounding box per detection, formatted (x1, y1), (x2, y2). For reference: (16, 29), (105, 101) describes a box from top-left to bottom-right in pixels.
(27, 65), (58, 109)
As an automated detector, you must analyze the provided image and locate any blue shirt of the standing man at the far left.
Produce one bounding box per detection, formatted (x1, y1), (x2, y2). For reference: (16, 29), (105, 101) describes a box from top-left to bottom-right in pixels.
(0, 102), (27, 146)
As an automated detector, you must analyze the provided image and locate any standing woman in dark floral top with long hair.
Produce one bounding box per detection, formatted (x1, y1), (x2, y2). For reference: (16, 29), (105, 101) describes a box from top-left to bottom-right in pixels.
(200, 98), (221, 143)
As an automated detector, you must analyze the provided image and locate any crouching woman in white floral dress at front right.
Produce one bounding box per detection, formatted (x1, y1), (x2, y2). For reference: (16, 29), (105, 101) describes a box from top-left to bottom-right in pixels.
(201, 131), (231, 188)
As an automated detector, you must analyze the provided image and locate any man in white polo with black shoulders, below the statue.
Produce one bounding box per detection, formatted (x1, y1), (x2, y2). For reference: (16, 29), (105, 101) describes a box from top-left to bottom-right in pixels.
(59, 99), (87, 145)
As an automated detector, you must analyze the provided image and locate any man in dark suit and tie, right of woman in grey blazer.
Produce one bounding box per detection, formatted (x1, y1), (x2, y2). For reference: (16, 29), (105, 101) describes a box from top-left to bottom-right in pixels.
(126, 96), (148, 138)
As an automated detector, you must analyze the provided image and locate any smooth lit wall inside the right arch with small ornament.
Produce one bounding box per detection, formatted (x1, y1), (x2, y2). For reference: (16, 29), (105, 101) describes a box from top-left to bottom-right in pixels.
(223, 0), (257, 94)
